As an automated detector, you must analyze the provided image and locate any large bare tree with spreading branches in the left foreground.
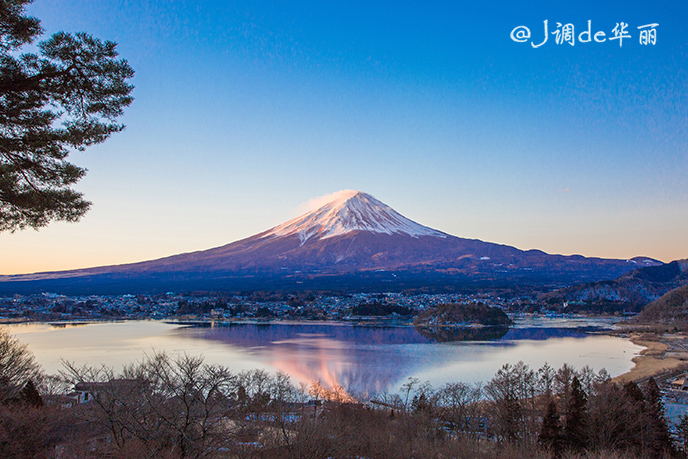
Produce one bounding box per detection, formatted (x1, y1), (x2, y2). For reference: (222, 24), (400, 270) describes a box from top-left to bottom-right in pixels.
(63, 354), (236, 457)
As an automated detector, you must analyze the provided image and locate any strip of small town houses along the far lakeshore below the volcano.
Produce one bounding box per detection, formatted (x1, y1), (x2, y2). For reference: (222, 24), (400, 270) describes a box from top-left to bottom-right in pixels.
(0, 292), (532, 321)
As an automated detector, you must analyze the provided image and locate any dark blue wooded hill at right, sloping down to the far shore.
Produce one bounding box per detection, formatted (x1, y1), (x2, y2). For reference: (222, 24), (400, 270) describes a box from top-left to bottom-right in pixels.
(541, 260), (688, 310)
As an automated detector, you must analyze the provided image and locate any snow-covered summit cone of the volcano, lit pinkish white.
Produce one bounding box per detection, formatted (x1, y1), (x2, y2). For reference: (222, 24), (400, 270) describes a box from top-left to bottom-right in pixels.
(264, 190), (447, 244)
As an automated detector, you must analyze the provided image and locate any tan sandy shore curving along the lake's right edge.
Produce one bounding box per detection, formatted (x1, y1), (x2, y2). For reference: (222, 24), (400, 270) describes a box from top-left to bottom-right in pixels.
(613, 333), (688, 384)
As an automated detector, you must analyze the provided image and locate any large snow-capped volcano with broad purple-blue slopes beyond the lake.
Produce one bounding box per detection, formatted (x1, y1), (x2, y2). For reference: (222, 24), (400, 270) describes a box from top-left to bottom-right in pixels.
(0, 191), (661, 291)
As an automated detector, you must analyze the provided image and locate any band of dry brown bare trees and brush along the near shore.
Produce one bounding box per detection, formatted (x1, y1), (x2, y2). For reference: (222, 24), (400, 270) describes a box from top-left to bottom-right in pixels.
(0, 326), (683, 458)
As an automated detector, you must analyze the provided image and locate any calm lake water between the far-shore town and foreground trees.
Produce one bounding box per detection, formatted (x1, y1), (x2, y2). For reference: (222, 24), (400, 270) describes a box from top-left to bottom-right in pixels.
(9, 318), (643, 394)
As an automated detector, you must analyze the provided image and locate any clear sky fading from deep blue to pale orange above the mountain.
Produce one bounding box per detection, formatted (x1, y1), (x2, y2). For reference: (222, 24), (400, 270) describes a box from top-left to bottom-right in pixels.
(0, 0), (688, 274)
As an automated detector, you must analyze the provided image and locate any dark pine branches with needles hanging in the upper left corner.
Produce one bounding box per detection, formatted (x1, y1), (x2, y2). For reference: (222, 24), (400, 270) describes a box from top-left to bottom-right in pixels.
(0, 0), (134, 231)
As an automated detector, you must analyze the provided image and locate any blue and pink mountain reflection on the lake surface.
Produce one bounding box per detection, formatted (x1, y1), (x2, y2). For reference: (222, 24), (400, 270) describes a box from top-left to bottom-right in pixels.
(173, 323), (612, 395)
